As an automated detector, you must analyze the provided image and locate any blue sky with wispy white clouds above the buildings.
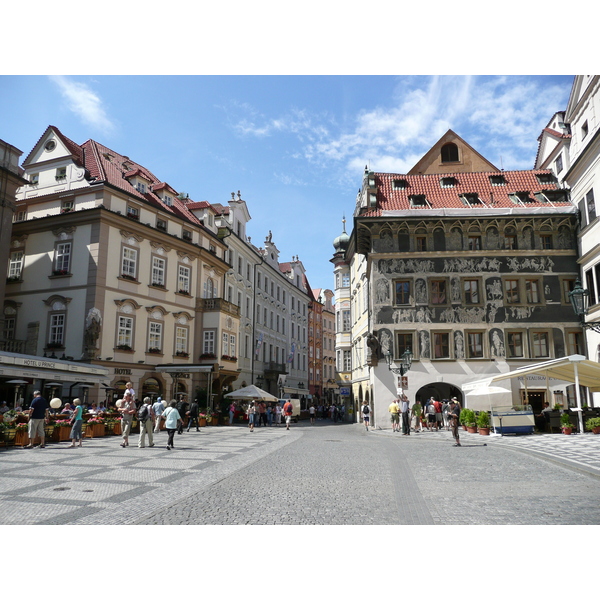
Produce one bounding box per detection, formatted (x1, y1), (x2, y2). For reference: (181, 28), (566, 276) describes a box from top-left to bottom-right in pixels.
(0, 75), (573, 288)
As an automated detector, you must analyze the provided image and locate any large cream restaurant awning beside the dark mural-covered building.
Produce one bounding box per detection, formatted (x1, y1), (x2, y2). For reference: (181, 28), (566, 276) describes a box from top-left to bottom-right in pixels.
(463, 354), (600, 392)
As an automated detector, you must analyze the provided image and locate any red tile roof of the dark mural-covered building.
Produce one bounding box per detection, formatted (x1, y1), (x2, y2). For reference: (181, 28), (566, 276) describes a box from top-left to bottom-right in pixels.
(362, 170), (571, 217)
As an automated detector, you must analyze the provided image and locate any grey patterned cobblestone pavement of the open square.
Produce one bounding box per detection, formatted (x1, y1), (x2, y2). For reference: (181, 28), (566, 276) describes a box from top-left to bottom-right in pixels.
(0, 422), (600, 525)
